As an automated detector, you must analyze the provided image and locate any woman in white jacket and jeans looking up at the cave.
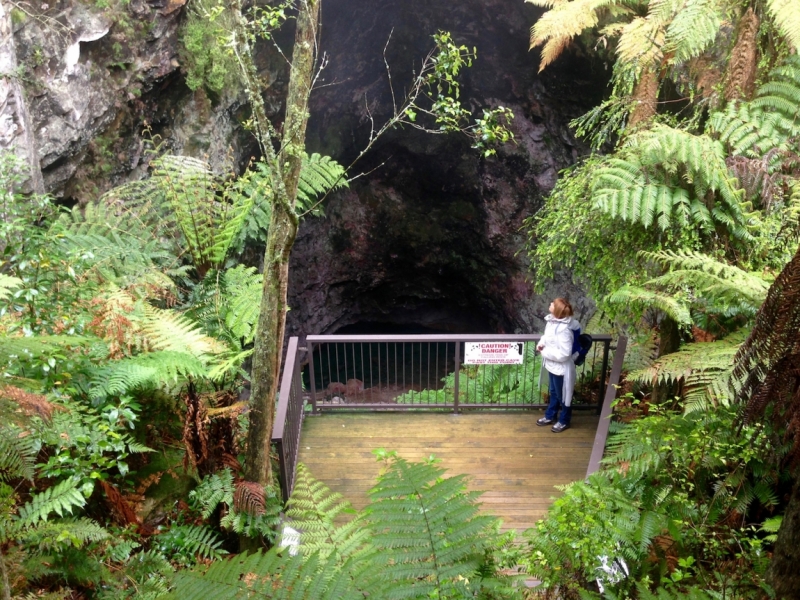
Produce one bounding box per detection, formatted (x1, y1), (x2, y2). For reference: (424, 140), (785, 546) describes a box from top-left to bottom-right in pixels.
(536, 298), (581, 433)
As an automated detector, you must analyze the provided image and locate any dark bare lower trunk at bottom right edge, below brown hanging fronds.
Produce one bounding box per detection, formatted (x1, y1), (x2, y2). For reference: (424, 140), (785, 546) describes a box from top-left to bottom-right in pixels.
(767, 481), (800, 599)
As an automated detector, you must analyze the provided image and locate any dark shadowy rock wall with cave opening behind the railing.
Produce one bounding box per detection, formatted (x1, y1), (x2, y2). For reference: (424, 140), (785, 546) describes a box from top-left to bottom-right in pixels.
(289, 0), (605, 335)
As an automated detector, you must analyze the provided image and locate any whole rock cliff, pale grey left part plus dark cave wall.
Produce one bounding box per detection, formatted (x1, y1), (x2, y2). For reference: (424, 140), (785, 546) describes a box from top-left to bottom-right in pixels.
(9, 0), (607, 335)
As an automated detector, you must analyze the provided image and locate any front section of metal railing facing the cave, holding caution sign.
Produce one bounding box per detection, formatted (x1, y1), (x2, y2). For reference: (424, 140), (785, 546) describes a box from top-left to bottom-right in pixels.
(303, 334), (611, 413)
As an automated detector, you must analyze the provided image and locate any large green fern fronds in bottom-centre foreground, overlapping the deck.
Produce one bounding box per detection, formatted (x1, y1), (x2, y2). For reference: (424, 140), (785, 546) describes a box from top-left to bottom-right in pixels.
(173, 458), (514, 600)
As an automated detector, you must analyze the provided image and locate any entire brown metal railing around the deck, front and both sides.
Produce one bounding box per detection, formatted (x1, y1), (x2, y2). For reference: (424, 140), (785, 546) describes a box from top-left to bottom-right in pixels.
(272, 334), (625, 500)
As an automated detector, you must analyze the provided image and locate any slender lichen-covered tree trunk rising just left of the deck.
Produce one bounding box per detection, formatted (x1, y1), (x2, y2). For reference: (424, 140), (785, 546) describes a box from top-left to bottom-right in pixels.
(245, 0), (320, 485)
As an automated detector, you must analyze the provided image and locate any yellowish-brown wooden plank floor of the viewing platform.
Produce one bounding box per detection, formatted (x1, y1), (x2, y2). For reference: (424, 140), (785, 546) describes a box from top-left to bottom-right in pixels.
(299, 411), (598, 530)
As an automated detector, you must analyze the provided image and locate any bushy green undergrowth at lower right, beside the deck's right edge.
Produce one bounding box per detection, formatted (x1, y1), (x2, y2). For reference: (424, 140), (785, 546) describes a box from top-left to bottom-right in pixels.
(527, 405), (776, 598)
